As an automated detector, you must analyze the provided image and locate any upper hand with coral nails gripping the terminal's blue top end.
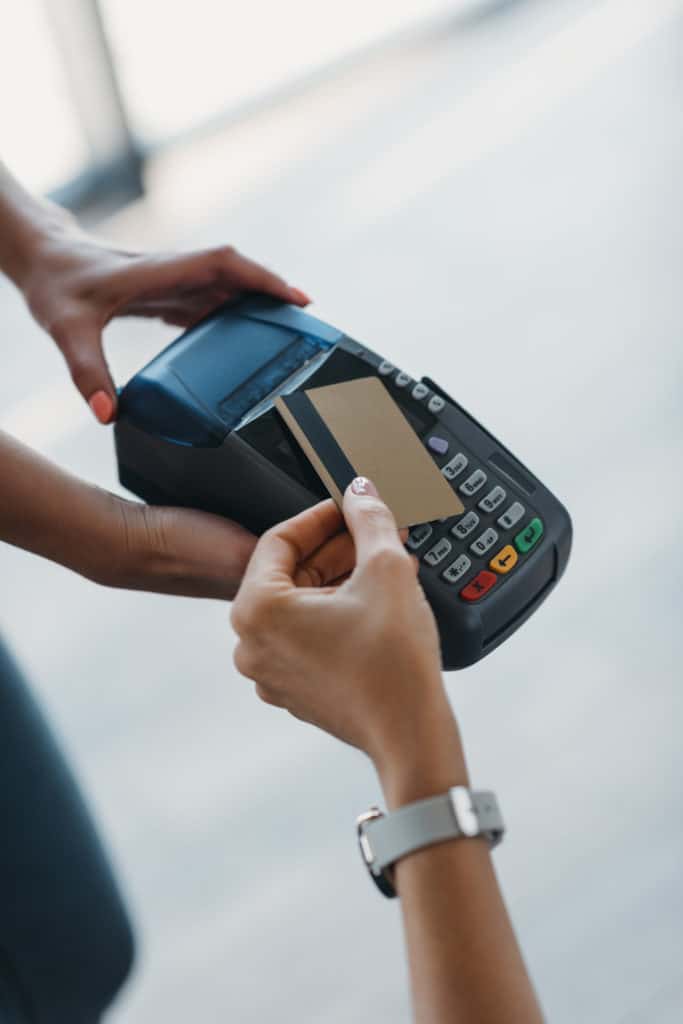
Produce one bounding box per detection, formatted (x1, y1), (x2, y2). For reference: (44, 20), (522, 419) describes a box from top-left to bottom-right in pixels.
(0, 164), (310, 423)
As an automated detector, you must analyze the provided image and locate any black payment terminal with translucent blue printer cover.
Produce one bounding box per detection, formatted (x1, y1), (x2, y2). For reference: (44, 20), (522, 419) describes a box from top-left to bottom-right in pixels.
(115, 297), (571, 669)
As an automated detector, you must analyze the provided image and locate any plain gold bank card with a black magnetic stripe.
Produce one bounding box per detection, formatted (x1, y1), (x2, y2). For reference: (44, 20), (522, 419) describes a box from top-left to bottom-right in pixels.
(275, 377), (464, 528)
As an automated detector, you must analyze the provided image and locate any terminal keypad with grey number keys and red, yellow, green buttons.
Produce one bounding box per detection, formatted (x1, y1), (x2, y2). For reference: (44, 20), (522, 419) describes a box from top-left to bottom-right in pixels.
(375, 360), (544, 603)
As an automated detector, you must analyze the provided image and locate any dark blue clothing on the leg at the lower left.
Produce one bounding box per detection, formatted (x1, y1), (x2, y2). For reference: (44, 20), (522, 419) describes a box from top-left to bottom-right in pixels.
(0, 643), (133, 1024)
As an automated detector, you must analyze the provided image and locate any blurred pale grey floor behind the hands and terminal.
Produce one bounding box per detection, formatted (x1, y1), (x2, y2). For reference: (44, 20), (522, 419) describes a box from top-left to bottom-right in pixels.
(0, 0), (683, 1024)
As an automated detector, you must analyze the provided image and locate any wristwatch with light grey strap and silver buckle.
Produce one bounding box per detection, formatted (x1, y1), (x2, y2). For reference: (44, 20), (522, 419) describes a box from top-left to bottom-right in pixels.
(356, 785), (505, 898)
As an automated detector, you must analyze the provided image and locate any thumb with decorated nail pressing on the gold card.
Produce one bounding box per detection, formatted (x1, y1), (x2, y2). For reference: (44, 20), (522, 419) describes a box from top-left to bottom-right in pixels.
(343, 476), (412, 571)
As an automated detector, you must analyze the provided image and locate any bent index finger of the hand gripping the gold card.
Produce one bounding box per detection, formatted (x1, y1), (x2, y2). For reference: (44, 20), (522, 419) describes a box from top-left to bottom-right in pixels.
(242, 499), (344, 589)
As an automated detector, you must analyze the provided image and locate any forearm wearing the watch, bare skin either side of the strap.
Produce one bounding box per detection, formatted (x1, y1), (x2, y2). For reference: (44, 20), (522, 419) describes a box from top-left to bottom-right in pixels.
(378, 707), (543, 1024)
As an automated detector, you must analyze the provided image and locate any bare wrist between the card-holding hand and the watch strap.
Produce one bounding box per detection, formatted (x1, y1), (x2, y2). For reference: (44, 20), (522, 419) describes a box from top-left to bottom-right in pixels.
(373, 684), (469, 810)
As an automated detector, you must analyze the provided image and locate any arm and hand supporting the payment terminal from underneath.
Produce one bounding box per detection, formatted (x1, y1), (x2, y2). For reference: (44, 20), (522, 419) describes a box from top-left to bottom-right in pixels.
(0, 431), (255, 600)
